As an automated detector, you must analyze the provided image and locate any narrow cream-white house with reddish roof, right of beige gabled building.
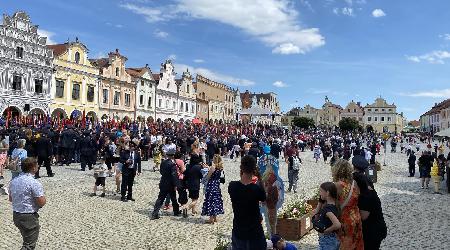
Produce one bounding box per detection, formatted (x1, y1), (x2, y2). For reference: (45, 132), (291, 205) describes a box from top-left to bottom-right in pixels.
(126, 64), (156, 121)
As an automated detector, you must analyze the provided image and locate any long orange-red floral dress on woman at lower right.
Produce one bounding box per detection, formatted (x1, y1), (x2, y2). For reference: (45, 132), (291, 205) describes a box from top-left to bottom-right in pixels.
(338, 181), (364, 250)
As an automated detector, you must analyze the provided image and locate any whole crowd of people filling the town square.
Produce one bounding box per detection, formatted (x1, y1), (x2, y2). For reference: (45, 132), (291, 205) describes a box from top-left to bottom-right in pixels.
(0, 121), (449, 249)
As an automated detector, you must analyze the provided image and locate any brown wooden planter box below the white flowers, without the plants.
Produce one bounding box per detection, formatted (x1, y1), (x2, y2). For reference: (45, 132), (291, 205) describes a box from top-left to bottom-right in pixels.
(277, 213), (312, 241)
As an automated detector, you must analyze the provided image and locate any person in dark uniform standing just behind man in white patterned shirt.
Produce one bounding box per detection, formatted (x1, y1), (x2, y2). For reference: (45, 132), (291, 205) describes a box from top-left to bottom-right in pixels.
(34, 131), (55, 179)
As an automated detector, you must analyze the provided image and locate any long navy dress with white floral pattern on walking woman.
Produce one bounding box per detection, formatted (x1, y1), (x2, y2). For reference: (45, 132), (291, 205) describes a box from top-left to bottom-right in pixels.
(202, 170), (224, 216)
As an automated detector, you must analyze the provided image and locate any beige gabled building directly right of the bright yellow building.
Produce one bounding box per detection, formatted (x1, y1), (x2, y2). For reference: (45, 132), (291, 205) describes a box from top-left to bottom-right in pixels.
(90, 49), (136, 120)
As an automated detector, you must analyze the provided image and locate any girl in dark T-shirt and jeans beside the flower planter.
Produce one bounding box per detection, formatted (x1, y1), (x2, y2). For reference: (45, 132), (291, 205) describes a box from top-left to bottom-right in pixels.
(313, 182), (341, 250)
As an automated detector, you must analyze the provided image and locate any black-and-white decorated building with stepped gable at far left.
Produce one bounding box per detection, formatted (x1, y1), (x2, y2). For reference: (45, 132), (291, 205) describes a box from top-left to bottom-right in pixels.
(0, 11), (53, 116)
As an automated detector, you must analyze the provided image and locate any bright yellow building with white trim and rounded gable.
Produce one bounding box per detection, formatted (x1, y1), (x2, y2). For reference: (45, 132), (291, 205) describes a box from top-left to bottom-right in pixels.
(47, 38), (99, 120)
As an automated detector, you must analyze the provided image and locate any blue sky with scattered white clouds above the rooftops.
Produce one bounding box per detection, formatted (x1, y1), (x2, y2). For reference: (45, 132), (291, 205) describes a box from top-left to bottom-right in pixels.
(4, 0), (450, 119)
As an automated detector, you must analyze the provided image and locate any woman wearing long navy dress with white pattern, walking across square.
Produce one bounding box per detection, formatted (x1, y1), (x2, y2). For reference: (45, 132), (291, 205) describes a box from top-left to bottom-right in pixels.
(202, 154), (224, 224)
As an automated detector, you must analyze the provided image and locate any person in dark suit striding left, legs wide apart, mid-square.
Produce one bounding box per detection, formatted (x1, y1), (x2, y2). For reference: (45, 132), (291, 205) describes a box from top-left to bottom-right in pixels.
(151, 148), (181, 220)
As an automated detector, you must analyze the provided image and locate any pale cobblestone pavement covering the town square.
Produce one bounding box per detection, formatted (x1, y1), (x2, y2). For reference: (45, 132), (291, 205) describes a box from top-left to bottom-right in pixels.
(0, 146), (450, 250)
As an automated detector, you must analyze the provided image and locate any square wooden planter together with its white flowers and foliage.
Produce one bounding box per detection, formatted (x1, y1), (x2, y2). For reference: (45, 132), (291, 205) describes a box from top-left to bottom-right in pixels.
(277, 200), (313, 240)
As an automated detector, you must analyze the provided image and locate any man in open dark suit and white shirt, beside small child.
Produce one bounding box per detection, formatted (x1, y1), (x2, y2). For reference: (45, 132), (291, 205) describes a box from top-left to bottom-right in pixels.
(119, 142), (141, 202)
